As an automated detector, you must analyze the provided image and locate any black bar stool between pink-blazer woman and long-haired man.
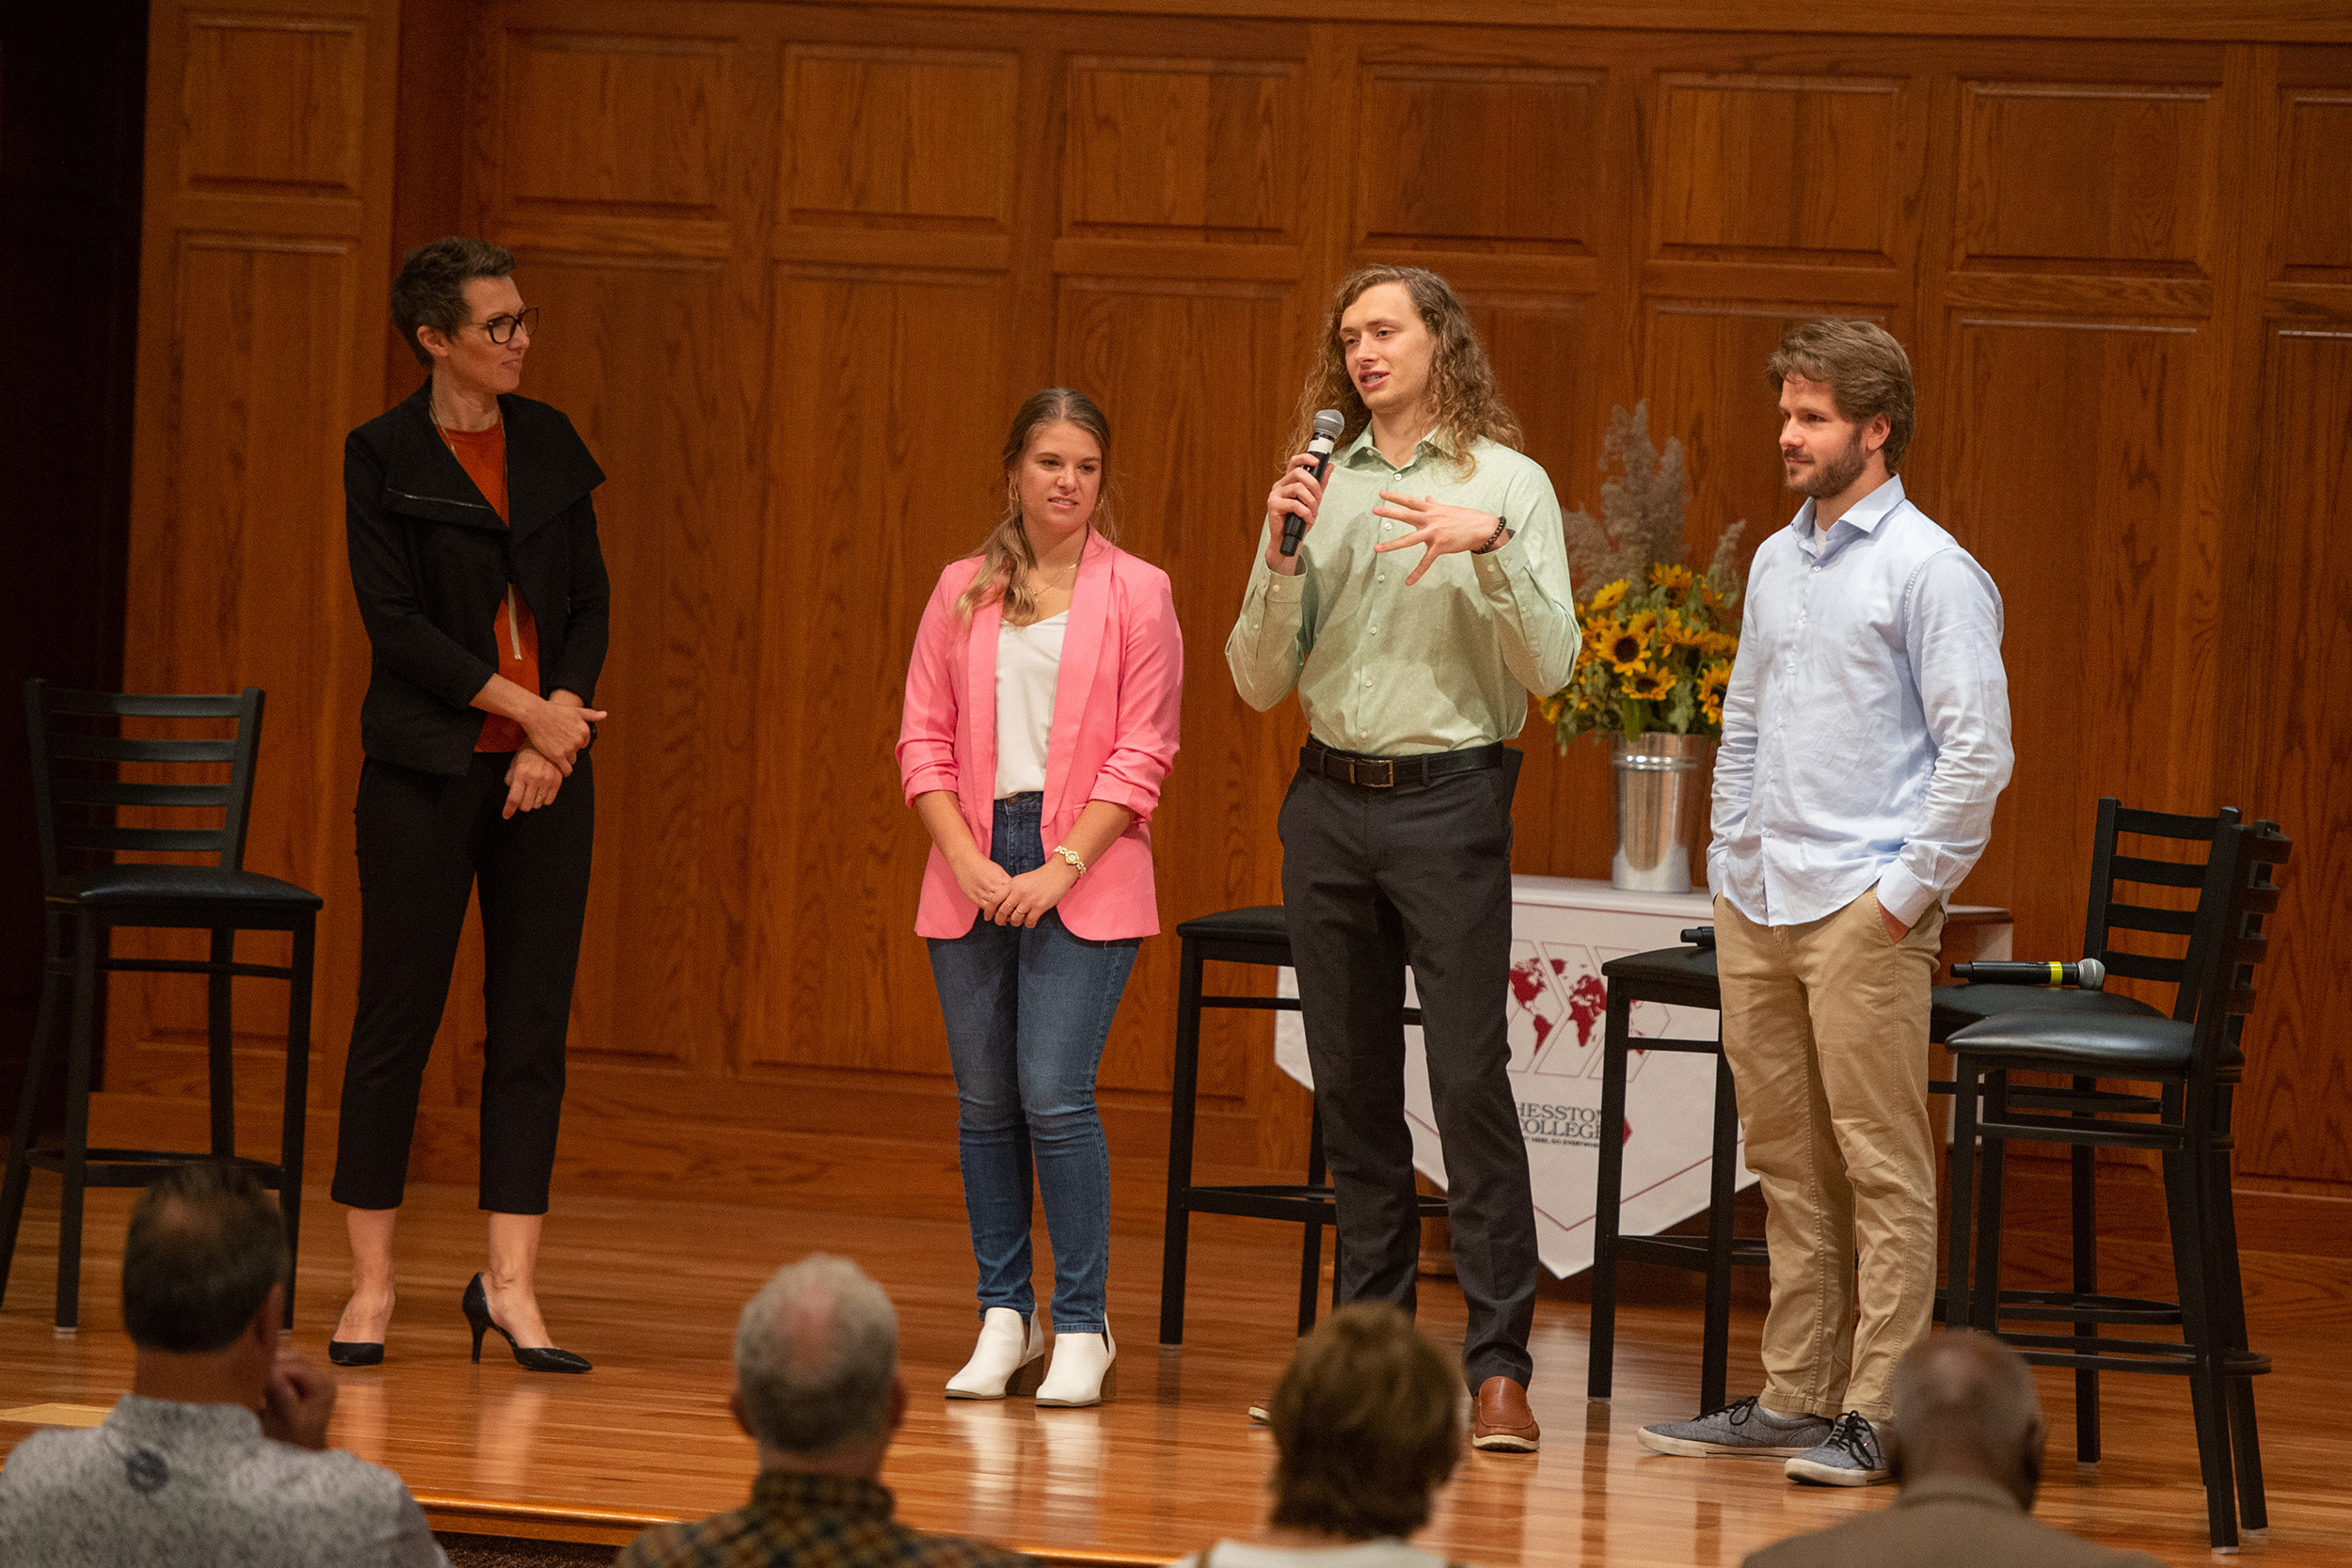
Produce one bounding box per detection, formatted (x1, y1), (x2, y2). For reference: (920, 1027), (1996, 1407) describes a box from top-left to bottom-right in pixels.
(1160, 903), (1447, 1345)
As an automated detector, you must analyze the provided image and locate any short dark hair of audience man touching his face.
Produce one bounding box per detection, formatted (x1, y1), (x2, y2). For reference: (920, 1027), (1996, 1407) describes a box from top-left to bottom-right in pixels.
(122, 1159), (292, 1354)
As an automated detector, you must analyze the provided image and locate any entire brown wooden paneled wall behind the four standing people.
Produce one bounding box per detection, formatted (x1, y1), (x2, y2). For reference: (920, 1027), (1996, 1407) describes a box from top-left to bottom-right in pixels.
(108, 0), (2352, 1195)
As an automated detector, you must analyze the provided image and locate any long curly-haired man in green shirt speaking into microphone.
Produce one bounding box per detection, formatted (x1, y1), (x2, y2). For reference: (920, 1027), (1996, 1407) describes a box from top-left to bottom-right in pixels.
(1226, 268), (1581, 1453)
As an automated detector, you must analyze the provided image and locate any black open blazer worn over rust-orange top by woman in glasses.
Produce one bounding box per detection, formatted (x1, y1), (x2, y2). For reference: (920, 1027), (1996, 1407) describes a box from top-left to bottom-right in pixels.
(343, 381), (612, 773)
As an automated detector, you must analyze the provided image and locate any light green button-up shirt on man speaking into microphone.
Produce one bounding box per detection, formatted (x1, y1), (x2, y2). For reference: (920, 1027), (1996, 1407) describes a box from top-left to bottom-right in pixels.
(1226, 425), (1579, 754)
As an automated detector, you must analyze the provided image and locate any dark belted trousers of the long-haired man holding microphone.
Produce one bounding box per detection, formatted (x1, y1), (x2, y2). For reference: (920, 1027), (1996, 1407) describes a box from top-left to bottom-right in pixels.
(1279, 752), (1536, 1389)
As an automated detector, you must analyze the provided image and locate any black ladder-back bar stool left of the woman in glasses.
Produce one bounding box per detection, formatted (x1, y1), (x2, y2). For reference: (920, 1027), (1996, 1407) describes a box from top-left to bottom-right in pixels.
(0, 679), (320, 1331)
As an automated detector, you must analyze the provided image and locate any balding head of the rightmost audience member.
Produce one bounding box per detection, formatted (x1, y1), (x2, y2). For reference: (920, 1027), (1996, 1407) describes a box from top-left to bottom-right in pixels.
(1894, 1331), (2044, 1510)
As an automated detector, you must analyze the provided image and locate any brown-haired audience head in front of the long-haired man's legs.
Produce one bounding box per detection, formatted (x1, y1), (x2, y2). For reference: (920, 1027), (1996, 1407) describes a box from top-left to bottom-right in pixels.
(1268, 1303), (1463, 1540)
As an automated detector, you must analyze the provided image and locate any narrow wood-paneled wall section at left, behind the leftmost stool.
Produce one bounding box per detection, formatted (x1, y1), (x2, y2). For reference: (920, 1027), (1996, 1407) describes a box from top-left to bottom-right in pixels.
(106, 0), (400, 1101)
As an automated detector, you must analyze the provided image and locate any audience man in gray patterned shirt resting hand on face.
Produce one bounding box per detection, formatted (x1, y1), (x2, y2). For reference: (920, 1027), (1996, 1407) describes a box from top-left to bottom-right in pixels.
(0, 1164), (447, 1568)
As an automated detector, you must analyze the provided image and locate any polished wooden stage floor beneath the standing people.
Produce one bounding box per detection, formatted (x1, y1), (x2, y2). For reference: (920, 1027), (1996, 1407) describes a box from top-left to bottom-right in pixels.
(0, 1182), (2352, 1566)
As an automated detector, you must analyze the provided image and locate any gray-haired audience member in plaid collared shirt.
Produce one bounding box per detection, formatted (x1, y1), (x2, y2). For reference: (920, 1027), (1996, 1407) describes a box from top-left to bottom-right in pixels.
(619, 1253), (1035, 1568)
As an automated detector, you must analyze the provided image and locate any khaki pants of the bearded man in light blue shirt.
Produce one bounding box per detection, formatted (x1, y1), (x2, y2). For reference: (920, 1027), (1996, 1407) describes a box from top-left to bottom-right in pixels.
(1715, 889), (1943, 1420)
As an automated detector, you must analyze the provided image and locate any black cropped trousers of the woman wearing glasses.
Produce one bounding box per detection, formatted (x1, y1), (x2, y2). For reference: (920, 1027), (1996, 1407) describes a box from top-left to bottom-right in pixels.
(334, 752), (596, 1213)
